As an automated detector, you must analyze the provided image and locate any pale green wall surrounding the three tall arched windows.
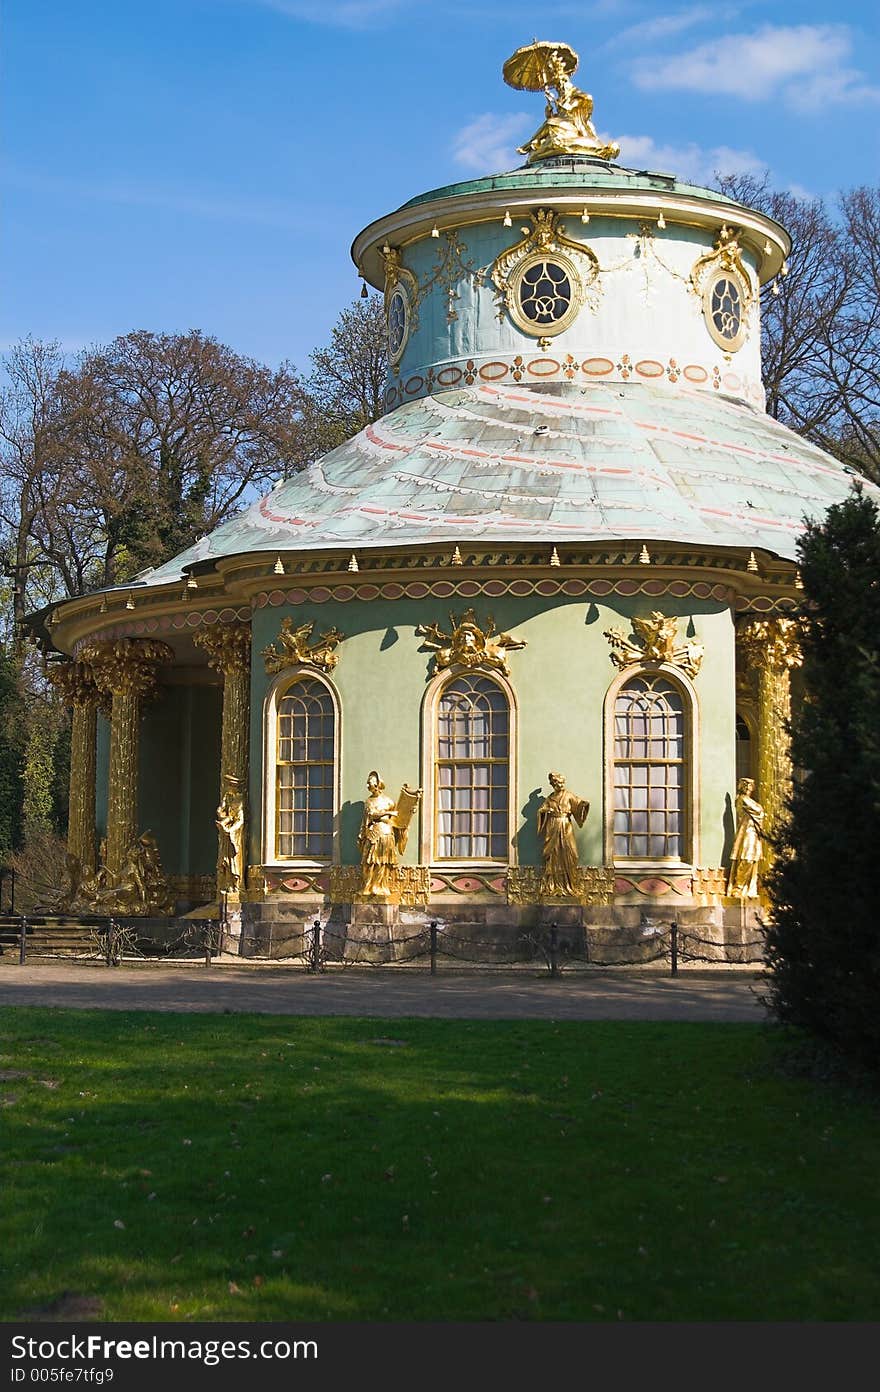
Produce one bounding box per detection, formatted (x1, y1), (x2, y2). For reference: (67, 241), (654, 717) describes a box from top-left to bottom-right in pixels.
(251, 596), (735, 866)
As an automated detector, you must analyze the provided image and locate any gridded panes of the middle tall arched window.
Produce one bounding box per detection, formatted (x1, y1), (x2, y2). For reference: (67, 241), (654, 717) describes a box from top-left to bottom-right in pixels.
(434, 677), (510, 860)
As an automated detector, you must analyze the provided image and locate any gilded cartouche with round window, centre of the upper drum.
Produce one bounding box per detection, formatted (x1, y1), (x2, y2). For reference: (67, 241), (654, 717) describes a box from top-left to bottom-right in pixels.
(489, 207), (599, 337)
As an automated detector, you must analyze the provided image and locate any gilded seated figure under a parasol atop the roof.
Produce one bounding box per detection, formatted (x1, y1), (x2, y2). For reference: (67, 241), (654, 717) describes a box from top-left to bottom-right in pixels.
(503, 42), (620, 164)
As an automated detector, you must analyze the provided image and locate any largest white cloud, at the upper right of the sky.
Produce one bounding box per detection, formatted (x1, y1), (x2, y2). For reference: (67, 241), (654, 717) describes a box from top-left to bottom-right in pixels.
(634, 24), (880, 110)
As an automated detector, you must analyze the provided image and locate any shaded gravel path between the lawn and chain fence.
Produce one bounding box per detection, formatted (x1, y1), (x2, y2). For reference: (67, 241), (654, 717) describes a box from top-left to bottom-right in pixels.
(0, 956), (766, 1022)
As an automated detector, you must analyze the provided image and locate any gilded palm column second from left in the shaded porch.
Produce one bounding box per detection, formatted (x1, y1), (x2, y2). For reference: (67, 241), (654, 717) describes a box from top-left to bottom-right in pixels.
(79, 638), (174, 881)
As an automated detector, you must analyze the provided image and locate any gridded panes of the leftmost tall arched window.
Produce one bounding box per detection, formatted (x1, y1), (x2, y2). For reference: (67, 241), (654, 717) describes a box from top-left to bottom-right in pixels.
(276, 677), (336, 860)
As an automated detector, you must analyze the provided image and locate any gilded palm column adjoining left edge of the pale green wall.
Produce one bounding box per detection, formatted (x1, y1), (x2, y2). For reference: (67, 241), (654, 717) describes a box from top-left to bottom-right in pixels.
(194, 624), (251, 892)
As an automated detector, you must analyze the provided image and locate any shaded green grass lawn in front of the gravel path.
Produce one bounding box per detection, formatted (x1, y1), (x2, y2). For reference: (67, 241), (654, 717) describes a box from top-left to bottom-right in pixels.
(0, 1009), (880, 1321)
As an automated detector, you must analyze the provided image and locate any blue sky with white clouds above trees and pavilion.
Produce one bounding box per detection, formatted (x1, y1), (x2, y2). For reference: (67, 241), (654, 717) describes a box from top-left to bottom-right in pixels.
(0, 0), (880, 367)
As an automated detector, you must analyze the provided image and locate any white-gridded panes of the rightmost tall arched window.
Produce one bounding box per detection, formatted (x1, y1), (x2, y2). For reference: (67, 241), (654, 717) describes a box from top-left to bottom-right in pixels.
(614, 677), (686, 860)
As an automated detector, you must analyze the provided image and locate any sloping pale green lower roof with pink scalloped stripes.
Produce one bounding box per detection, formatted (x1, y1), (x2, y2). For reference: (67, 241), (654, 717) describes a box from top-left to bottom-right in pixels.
(139, 383), (880, 585)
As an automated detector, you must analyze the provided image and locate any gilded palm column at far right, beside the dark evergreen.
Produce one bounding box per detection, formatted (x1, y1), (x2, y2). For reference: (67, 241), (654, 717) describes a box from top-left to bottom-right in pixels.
(737, 618), (801, 870)
